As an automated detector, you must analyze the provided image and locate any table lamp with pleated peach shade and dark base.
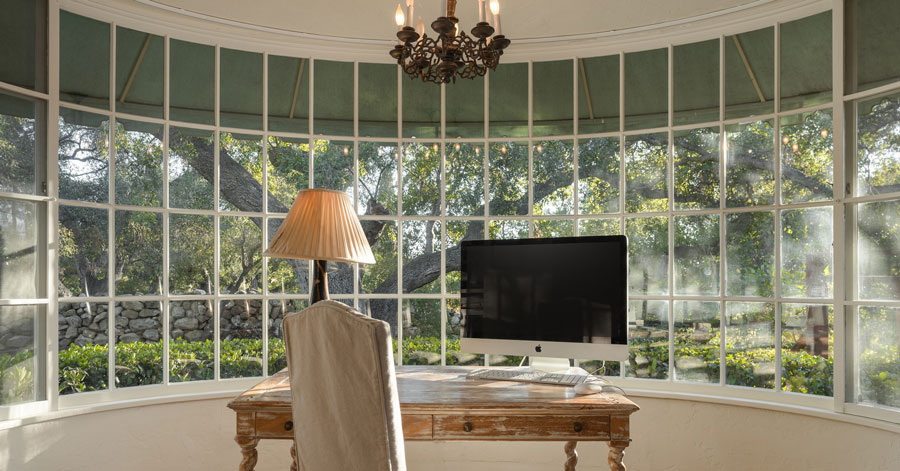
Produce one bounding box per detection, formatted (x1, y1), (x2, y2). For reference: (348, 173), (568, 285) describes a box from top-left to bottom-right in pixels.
(263, 189), (375, 305)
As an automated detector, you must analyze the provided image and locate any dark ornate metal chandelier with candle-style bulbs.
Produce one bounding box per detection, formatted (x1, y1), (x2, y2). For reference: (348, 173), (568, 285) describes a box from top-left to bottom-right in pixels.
(391, 0), (510, 83)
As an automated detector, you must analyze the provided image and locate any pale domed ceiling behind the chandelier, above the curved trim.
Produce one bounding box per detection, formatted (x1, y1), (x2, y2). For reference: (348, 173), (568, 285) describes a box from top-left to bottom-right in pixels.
(144, 0), (773, 41)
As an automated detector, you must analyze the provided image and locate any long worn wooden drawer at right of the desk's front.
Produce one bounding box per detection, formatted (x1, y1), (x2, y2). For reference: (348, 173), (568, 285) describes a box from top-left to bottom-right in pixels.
(434, 415), (609, 440)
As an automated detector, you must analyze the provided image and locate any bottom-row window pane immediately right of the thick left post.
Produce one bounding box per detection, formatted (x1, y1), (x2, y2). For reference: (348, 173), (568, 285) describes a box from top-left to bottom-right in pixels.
(58, 303), (109, 395)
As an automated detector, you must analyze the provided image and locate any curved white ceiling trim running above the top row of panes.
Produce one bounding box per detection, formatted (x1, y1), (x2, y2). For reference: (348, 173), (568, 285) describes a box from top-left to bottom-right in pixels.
(59, 0), (828, 63)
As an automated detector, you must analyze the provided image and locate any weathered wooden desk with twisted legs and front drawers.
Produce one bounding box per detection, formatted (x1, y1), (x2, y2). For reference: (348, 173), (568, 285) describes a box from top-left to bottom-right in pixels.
(228, 366), (638, 471)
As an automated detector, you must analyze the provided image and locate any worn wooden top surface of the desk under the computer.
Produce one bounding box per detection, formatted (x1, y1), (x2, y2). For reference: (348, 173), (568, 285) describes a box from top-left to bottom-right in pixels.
(228, 366), (638, 414)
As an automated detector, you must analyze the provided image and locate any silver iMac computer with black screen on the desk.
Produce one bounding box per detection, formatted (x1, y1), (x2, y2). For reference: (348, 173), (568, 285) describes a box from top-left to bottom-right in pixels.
(460, 235), (628, 370)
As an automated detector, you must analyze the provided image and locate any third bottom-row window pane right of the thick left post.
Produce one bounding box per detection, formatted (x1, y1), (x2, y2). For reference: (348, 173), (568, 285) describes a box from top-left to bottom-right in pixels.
(169, 299), (216, 383)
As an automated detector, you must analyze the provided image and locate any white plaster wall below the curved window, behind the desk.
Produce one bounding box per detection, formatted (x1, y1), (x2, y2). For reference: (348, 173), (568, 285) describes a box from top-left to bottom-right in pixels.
(0, 397), (900, 471)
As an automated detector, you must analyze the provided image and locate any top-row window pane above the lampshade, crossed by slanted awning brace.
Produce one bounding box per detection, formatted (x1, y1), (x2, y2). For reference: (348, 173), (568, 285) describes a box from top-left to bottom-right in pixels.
(268, 55), (309, 134)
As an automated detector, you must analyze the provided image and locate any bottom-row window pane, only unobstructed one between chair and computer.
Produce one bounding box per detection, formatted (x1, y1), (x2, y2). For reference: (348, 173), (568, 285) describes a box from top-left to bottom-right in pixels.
(402, 299), (441, 365)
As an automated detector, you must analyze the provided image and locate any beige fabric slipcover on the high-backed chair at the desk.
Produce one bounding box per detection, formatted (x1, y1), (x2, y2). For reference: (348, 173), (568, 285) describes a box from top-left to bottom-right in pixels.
(284, 301), (406, 471)
